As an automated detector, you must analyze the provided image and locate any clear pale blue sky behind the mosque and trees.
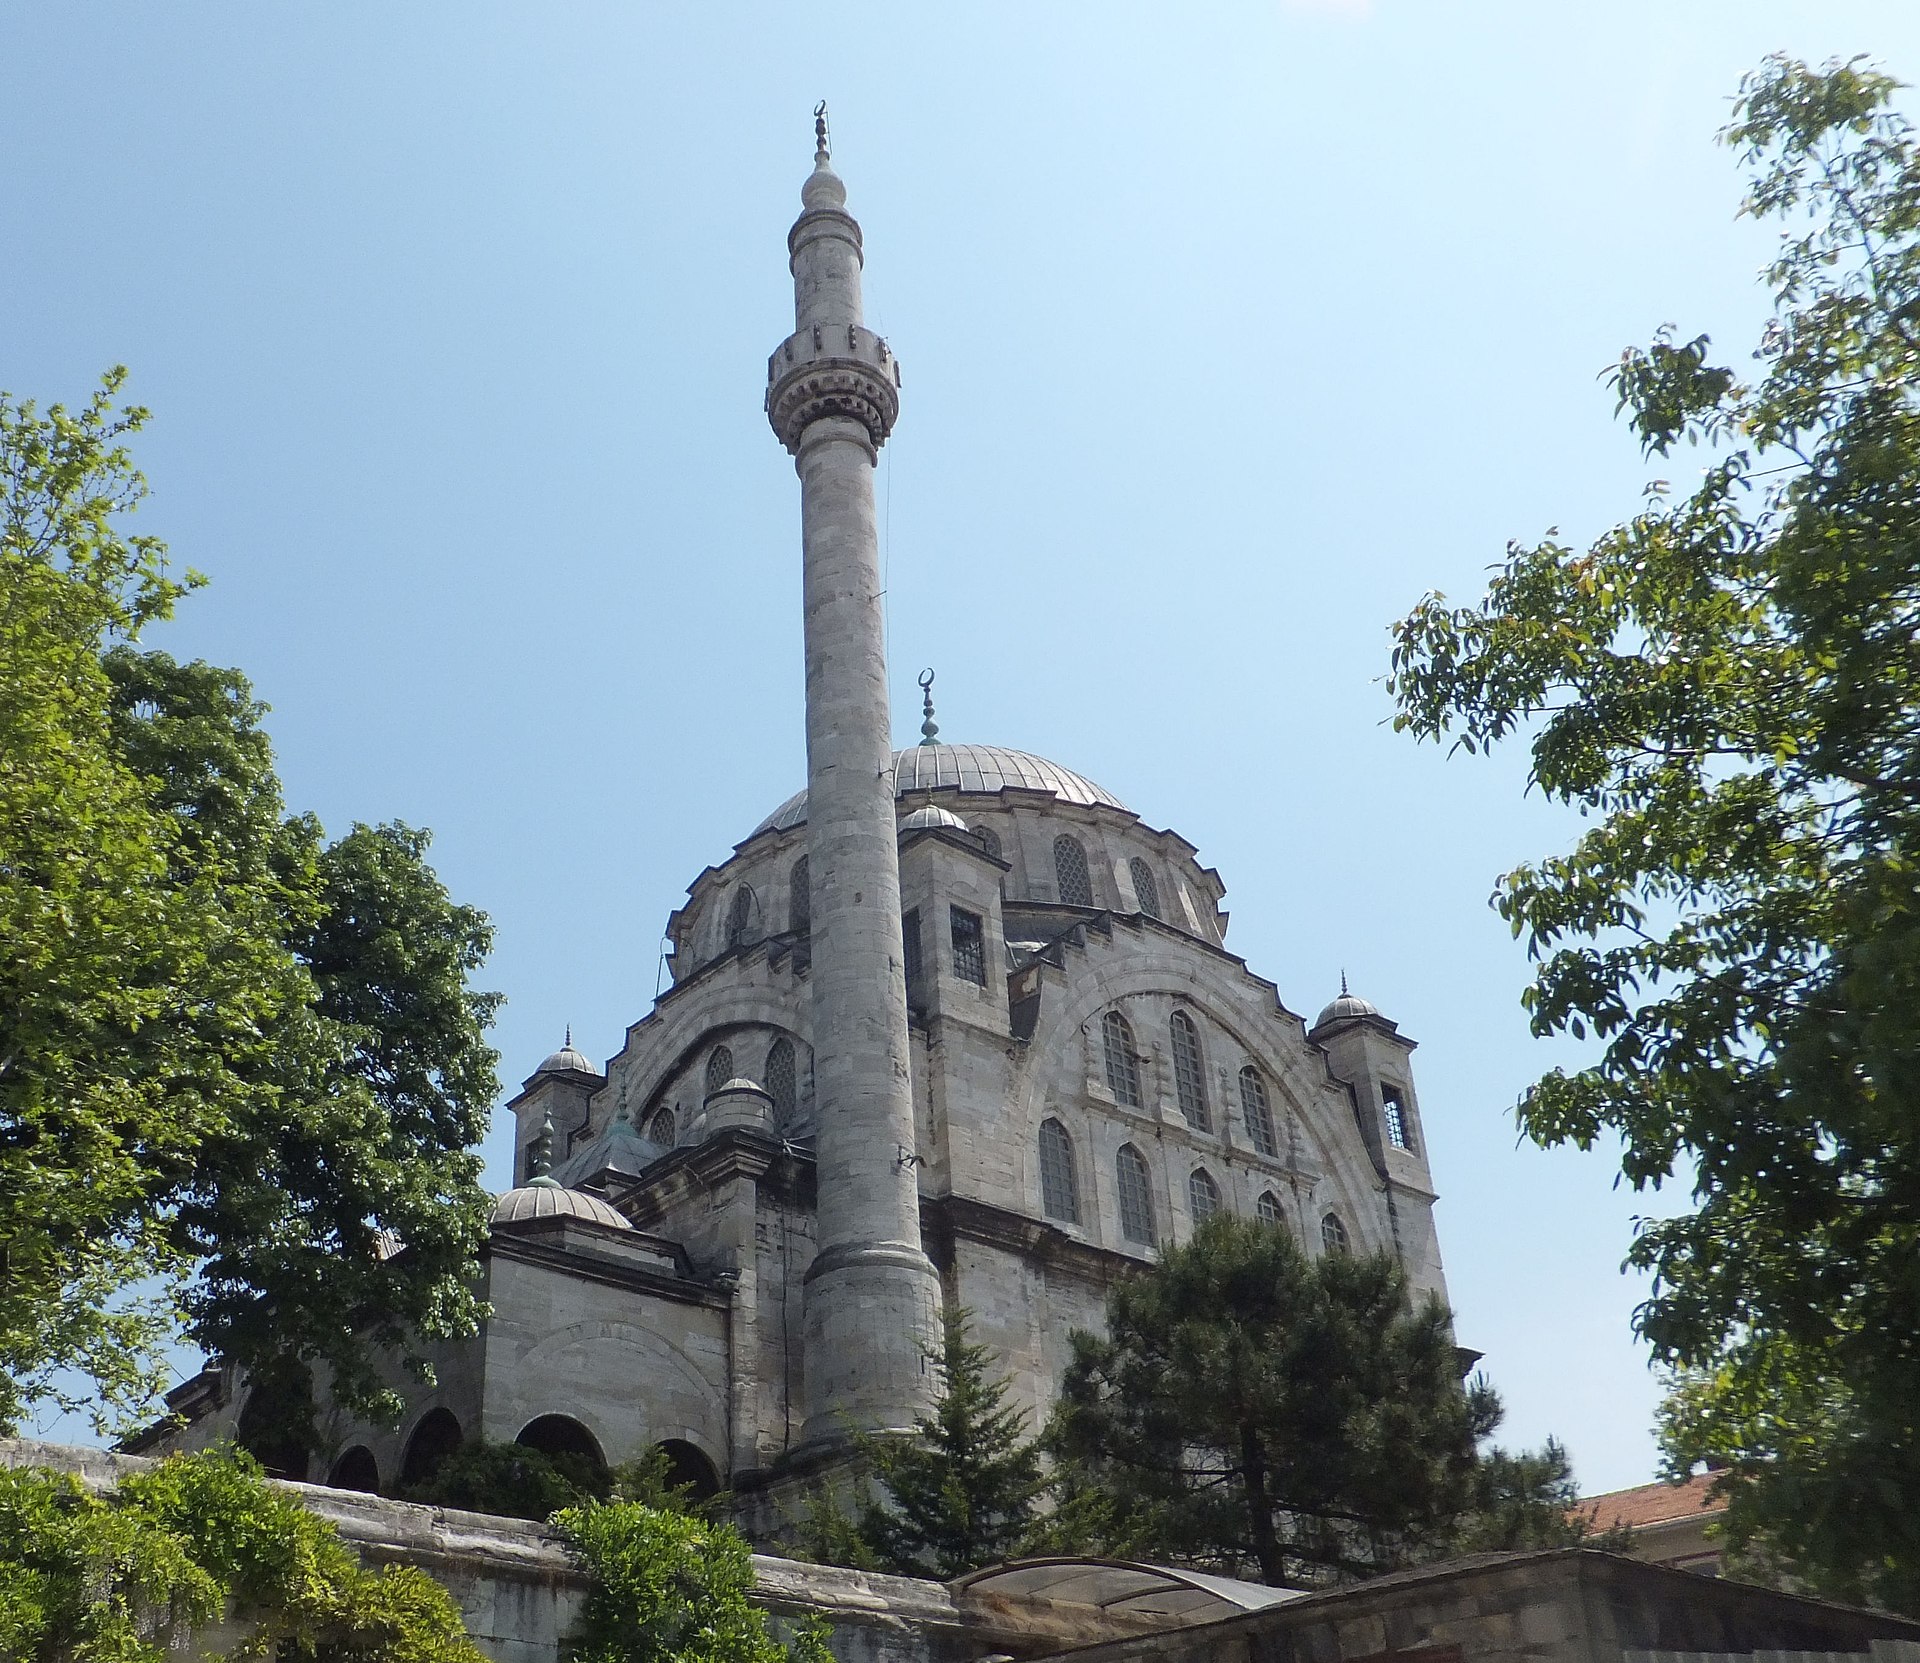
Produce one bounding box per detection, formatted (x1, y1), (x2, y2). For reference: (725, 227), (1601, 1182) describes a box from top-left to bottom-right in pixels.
(0, 0), (1920, 1490)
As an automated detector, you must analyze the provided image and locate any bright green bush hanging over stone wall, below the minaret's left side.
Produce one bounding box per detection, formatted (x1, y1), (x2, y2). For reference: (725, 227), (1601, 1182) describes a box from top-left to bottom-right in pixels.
(553, 1502), (833, 1663)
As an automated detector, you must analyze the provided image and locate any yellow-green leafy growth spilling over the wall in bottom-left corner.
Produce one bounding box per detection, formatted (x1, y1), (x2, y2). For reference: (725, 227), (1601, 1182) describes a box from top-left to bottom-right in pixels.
(0, 1452), (480, 1663)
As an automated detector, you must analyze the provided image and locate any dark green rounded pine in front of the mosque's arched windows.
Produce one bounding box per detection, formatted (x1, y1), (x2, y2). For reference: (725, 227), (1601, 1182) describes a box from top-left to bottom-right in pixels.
(1048, 1216), (1574, 1586)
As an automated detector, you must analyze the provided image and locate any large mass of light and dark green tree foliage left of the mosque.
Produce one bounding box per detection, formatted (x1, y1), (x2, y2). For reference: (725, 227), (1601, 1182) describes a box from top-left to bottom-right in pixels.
(0, 373), (497, 1436)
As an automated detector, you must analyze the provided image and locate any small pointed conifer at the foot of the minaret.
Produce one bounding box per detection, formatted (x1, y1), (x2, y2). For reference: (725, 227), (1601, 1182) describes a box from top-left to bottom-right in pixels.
(860, 1306), (1048, 1580)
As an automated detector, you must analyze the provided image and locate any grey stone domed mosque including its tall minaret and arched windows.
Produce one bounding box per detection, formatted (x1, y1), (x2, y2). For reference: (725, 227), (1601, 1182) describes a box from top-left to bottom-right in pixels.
(145, 123), (1446, 1538)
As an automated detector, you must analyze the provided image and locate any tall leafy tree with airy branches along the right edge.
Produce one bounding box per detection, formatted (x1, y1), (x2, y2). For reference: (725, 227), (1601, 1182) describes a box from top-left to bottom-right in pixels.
(1392, 58), (1920, 1611)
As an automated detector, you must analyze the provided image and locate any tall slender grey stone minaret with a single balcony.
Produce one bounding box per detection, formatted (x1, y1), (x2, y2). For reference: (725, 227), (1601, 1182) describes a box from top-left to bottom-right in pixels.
(766, 116), (939, 1442)
